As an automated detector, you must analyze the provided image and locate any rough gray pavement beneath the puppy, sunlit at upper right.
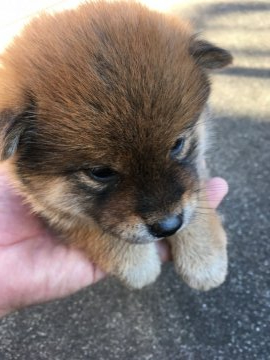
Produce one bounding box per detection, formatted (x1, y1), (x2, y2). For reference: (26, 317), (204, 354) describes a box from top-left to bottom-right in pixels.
(0, 0), (270, 360)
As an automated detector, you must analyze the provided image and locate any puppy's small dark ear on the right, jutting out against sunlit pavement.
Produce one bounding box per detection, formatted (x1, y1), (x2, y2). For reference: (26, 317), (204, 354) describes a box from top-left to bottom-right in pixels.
(190, 39), (233, 69)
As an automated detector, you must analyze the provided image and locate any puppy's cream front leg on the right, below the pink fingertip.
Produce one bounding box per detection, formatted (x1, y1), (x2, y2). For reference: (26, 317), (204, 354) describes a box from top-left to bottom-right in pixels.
(169, 205), (227, 290)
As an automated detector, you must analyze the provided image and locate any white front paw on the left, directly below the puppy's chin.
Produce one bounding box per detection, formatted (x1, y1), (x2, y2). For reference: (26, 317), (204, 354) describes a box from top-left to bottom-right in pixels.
(119, 244), (161, 289)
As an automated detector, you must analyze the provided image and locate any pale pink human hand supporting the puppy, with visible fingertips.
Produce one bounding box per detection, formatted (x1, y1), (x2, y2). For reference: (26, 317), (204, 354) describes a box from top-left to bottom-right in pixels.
(0, 164), (228, 317)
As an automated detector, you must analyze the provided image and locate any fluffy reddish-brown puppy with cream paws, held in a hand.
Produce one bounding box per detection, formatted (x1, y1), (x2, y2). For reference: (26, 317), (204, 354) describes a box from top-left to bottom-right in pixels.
(0, 1), (231, 290)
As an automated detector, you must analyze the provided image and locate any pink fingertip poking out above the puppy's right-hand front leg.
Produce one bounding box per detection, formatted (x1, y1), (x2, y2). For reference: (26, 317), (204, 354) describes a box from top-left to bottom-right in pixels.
(206, 177), (229, 209)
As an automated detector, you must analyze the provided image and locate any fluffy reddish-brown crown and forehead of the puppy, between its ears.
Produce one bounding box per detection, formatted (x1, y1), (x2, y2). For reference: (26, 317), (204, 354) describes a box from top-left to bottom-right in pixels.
(12, 3), (209, 165)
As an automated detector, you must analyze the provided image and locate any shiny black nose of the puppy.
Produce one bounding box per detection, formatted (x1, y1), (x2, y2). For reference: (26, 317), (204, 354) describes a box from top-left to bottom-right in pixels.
(148, 215), (183, 238)
